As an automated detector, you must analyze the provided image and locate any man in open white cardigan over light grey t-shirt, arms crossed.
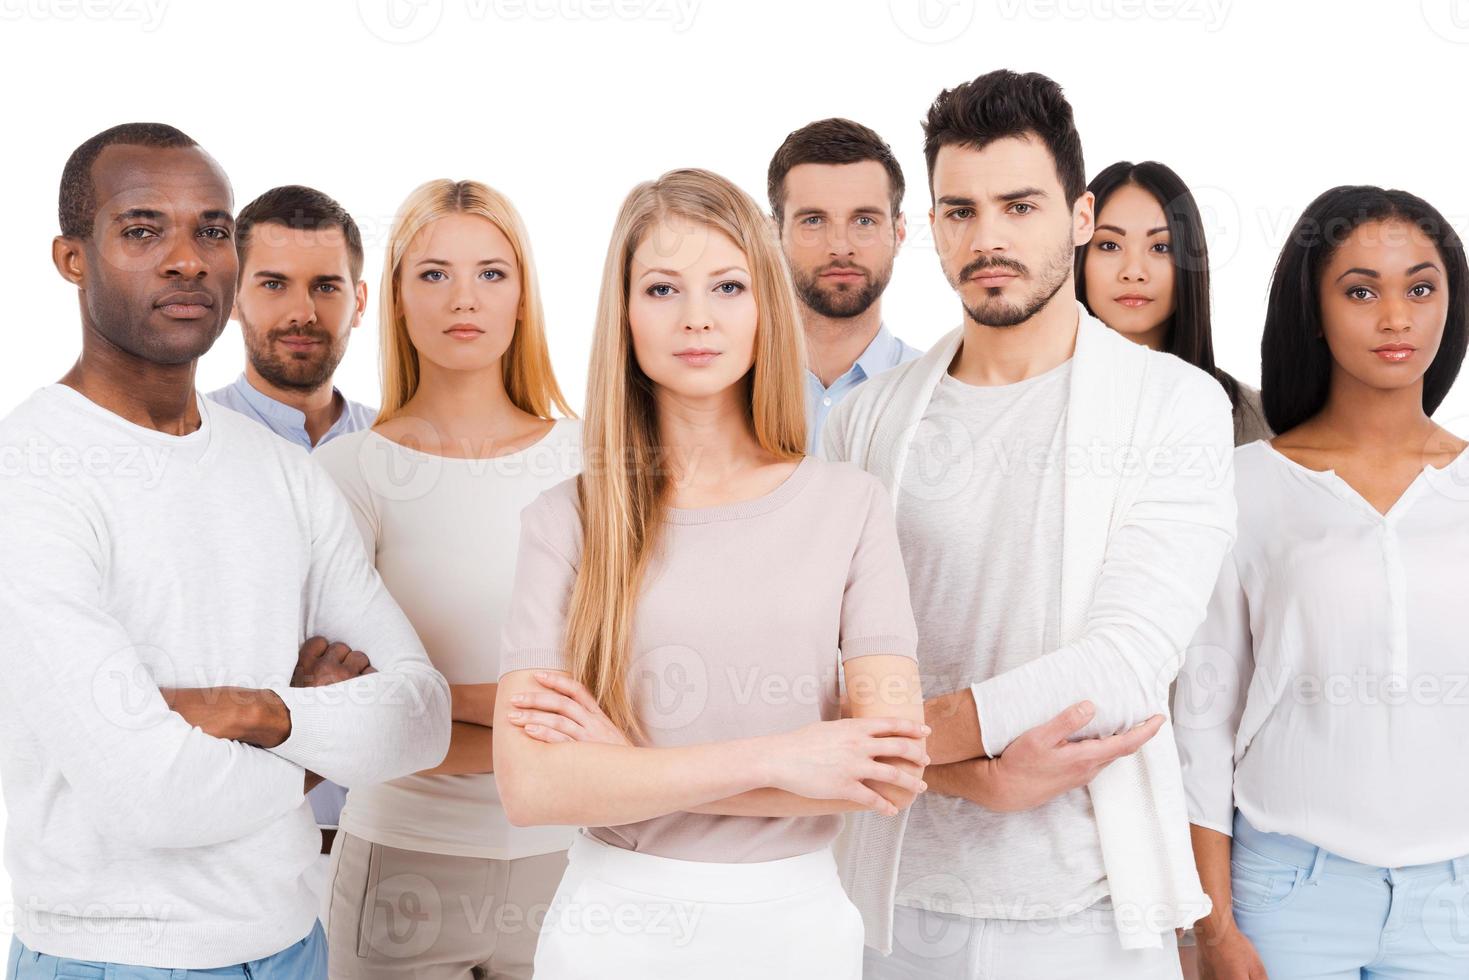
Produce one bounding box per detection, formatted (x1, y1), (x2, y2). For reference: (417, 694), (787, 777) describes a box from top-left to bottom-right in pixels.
(824, 71), (1234, 980)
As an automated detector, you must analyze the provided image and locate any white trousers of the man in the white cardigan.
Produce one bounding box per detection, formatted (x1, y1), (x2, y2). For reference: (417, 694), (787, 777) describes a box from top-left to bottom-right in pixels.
(864, 899), (1183, 980)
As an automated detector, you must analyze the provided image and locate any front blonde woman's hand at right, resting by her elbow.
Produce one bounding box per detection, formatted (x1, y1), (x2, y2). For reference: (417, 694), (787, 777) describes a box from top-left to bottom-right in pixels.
(757, 718), (933, 817)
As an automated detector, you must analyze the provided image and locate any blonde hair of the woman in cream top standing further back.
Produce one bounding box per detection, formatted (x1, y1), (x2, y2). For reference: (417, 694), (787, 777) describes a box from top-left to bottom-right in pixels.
(378, 179), (574, 425)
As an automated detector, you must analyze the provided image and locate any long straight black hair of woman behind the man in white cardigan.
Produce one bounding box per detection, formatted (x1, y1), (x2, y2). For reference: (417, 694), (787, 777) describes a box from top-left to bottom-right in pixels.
(1074, 160), (1240, 408)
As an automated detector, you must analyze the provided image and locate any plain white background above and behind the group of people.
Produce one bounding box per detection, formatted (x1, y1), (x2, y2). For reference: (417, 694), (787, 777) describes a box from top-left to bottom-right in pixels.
(0, 0), (1469, 948)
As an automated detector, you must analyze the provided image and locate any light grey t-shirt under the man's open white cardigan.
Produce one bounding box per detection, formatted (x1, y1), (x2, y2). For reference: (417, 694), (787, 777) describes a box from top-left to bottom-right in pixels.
(898, 360), (1108, 920)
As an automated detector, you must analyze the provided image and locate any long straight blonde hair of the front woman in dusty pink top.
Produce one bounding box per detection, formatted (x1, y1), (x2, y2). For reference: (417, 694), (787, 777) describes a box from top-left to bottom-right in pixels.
(566, 169), (806, 736)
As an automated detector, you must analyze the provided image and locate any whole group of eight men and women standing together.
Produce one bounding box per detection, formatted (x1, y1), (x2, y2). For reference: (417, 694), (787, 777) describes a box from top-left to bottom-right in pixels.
(0, 71), (1469, 980)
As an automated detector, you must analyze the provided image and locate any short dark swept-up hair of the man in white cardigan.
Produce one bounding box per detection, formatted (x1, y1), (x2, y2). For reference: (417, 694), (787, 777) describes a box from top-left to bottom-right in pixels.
(923, 69), (1087, 204)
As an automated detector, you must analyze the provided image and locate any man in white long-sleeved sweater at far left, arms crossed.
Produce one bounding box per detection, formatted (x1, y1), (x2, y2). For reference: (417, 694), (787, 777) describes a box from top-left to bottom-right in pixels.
(0, 123), (450, 980)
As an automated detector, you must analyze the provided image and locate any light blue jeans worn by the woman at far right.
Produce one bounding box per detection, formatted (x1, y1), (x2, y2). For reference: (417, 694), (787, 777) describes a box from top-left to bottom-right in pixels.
(1230, 811), (1469, 980)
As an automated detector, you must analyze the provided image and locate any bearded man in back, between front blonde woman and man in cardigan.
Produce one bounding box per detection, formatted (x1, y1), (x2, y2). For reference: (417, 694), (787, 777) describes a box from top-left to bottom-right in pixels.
(767, 119), (920, 453)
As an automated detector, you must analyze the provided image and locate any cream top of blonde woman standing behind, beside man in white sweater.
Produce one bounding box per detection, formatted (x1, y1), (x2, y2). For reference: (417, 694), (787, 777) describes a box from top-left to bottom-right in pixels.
(313, 419), (582, 860)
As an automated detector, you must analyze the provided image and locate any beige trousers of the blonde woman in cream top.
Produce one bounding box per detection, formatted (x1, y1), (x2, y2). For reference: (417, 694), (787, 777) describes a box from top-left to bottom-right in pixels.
(326, 830), (566, 980)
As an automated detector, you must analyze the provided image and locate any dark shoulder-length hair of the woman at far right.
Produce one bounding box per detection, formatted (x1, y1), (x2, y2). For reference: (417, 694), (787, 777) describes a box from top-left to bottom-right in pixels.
(1260, 185), (1469, 432)
